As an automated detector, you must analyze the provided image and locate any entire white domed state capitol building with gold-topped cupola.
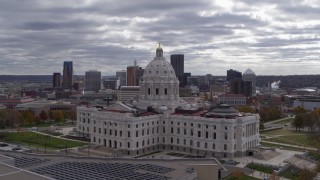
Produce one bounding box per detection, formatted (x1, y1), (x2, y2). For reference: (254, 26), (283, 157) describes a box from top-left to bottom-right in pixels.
(77, 45), (260, 158)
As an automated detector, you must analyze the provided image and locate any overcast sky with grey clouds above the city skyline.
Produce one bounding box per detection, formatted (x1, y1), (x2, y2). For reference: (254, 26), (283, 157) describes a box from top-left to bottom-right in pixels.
(0, 0), (320, 75)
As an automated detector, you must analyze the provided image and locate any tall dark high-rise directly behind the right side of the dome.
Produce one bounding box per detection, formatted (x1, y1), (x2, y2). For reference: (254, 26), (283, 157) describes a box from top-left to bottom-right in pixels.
(170, 54), (186, 87)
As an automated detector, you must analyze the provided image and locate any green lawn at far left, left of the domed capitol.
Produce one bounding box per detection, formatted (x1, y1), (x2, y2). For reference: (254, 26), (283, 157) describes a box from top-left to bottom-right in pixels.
(0, 132), (87, 149)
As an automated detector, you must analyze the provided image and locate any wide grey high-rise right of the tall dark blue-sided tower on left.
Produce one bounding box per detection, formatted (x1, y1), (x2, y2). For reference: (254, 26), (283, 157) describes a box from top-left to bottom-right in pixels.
(85, 70), (101, 91)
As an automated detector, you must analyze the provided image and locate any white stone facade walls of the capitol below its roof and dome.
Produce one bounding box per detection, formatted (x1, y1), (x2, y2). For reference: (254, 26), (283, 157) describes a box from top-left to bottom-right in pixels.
(77, 106), (259, 157)
